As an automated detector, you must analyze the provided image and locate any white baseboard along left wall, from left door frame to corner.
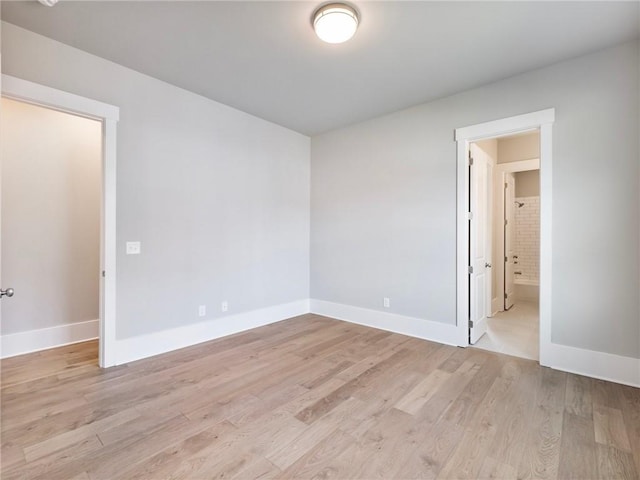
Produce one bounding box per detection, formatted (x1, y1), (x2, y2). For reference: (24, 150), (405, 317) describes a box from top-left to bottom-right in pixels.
(116, 299), (309, 365)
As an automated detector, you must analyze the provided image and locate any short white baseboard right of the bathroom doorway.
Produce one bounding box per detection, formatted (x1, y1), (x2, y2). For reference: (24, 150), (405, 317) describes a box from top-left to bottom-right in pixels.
(540, 343), (640, 387)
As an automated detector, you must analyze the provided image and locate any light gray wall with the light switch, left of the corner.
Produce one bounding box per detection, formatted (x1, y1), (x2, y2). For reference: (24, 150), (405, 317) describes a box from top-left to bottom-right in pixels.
(2, 23), (309, 338)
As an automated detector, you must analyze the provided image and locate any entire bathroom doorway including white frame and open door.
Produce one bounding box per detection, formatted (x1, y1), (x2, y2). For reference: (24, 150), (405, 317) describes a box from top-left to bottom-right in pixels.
(455, 109), (555, 365)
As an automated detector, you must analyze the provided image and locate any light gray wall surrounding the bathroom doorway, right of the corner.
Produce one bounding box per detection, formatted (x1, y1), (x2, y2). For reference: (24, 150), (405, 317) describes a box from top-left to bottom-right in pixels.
(311, 42), (640, 357)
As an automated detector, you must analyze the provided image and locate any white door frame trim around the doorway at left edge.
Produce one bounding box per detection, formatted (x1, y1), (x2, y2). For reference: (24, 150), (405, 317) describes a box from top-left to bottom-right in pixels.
(1, 74), (120, 367)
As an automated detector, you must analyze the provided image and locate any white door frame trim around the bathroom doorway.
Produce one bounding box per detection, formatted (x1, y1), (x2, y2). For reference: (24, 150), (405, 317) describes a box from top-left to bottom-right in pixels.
(455, 108), (555, 365)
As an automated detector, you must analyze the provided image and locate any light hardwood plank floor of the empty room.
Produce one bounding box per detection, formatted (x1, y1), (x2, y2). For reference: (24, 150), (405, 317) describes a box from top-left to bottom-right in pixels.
(1, 315), (640, 480)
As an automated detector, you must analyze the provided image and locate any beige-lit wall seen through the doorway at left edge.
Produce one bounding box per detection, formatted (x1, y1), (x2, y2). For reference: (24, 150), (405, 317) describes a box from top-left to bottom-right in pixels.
(0, 98), (102, 335)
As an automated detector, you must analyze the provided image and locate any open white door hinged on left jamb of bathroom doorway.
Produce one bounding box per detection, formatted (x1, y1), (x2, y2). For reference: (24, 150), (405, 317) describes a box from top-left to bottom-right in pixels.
(469, 143), (493, 344)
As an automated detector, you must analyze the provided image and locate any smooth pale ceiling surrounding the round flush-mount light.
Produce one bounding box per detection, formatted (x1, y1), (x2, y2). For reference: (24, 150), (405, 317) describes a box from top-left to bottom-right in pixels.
(2, 0), (640, 135)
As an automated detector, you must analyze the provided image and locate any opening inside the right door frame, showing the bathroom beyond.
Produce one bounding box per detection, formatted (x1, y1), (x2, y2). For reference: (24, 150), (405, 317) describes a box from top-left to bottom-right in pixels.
(469, 130), (540, 360)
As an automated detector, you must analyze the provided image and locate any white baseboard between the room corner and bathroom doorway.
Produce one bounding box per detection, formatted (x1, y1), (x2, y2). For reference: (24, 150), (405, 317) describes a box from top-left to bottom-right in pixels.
(310, 299), (459, 346)
